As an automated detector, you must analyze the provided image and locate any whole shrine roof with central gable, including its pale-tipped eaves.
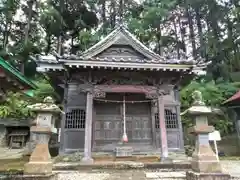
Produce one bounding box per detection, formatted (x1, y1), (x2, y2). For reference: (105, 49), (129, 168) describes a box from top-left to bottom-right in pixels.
(33, 25), (210, 72)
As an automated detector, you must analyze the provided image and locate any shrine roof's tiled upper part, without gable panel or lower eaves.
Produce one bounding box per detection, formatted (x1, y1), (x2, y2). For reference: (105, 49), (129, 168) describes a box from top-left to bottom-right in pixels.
(37, 25), (194, 64)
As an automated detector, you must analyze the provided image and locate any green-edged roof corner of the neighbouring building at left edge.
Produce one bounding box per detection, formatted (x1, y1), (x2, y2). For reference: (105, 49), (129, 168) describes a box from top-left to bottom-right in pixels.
(0, 57), (36, 99)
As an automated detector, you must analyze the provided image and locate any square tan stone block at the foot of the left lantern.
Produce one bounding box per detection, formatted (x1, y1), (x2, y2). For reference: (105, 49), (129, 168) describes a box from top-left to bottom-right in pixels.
(24, 162), (53, 175)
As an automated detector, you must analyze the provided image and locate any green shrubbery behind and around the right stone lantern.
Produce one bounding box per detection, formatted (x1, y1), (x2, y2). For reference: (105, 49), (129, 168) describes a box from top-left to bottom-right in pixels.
(180, 80), (238, 134)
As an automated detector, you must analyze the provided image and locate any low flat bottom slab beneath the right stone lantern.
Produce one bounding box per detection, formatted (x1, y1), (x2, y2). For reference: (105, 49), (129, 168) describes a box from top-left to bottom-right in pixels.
(186, 171), (231, 180)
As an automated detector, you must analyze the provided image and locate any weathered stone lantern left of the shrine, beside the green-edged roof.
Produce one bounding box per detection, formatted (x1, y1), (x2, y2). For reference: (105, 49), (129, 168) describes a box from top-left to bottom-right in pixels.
(24, 97), (61, 175)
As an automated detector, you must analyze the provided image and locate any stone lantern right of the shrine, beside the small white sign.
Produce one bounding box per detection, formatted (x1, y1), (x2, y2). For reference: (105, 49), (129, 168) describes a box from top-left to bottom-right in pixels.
(181, 91), (230, 180)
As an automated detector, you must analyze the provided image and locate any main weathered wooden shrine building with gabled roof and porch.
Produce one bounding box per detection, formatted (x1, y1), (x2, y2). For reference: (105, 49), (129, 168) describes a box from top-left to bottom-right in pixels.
(32, 26), (205, 160)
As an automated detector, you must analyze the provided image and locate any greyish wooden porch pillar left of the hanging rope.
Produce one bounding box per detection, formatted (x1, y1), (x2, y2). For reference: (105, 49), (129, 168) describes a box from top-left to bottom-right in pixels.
(82, 91), (93, 163)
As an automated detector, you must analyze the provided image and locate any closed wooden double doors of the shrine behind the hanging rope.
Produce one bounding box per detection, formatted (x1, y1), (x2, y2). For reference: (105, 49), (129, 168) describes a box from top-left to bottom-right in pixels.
(93, 94), (152, 151)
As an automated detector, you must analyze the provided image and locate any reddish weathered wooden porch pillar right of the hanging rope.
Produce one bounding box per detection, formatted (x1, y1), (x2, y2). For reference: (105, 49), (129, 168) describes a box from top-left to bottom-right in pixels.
(158, 94), (168, 161)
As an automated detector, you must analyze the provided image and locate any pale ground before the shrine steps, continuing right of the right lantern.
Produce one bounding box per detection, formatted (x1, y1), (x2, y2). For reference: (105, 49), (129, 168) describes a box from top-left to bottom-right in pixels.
(54, 161), (240, 180)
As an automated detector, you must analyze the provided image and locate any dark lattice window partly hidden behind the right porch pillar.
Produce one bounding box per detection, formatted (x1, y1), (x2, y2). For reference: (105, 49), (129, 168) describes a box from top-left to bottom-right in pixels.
(155, 108), (178, 129)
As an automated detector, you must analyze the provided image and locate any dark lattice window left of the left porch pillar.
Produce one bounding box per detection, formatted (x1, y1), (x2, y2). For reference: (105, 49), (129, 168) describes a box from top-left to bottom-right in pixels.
(65, 109), (86, 129)
